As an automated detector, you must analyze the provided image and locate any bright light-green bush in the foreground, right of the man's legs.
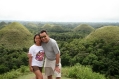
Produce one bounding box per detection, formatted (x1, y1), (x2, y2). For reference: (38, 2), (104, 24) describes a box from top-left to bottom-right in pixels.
(62, 64), (106, 79)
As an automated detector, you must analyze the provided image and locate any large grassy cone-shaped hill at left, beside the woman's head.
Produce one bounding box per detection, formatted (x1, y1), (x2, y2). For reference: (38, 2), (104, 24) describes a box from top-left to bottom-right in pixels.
(0, 22), (33, 49)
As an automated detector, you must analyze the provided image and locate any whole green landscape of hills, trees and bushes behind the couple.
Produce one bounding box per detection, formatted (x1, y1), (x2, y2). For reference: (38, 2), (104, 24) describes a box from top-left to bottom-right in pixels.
(0, 22), (119, 79)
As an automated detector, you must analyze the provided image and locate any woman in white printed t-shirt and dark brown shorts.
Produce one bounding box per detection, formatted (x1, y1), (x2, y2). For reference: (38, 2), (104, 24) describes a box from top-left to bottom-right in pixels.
(28, 34), (44, 79)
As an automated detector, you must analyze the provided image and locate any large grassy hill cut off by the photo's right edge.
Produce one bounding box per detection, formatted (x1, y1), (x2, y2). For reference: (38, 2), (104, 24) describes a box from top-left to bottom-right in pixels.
(85, 26), (119, 42)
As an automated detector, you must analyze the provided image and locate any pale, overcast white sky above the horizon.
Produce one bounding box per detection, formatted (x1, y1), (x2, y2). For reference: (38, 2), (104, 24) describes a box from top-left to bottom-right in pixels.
(0, 0), (119, 22)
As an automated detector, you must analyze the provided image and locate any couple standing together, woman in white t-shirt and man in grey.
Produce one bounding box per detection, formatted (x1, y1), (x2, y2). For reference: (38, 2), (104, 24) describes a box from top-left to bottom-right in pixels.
(28, 30), (61, 79)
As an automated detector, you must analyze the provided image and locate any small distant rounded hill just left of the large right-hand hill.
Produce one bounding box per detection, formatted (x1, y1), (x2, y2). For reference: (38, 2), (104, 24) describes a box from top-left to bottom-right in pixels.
(73, 24), (94, 33)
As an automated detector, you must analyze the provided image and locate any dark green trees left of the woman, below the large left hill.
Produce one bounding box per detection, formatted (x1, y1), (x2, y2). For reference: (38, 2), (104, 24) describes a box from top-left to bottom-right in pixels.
(0, 47), (28, 74)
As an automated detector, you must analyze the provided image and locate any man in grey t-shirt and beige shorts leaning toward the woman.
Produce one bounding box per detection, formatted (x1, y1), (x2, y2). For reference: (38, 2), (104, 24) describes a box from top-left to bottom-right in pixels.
(40, 30), (61, 79)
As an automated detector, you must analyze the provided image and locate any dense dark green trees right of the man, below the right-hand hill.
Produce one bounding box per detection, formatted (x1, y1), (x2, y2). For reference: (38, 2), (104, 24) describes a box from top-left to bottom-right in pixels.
(61, 40), (119, 77)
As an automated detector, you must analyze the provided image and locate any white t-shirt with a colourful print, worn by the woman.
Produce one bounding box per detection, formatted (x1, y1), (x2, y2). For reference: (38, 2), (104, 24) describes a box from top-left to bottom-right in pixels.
(29, 44), (44, 67)
